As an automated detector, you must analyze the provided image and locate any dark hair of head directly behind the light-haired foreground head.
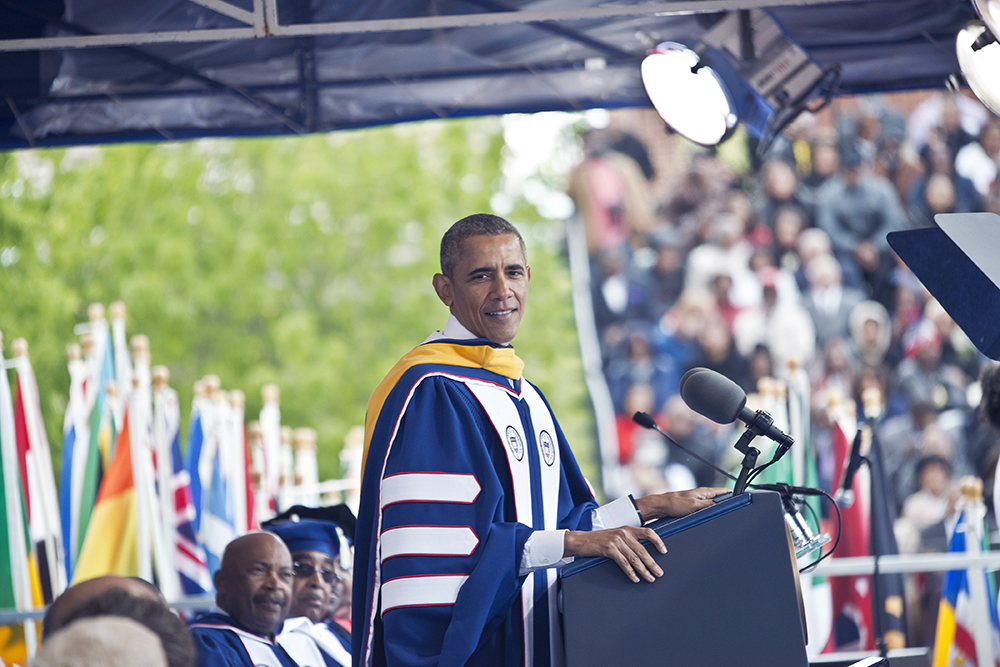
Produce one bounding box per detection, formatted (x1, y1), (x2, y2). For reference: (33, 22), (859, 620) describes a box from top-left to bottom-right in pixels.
(62, 587), (195, 667)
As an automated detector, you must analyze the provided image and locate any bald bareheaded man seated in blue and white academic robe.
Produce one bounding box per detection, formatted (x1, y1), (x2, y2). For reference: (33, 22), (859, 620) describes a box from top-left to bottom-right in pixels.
(191, 531), (325, 667)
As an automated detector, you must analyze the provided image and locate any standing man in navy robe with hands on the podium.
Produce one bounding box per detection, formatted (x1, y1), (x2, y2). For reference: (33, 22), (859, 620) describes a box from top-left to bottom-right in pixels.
(353, 214), (726, 667)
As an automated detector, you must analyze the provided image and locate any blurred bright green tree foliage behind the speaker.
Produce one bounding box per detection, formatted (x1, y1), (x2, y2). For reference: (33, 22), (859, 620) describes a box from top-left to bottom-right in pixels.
(0, 119), (596, 486)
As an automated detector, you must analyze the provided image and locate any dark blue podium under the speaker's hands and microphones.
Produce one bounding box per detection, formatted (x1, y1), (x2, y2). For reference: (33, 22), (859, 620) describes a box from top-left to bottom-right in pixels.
(561, 491), (809, 667)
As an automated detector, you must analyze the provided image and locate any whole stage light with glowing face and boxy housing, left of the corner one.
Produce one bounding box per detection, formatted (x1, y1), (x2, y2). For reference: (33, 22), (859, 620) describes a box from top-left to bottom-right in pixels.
(642, 9), (839, 153)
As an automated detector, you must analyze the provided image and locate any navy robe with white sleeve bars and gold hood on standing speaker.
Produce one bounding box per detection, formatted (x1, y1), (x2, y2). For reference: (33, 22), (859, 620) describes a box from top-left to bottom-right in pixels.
(353, 339), (597, 667)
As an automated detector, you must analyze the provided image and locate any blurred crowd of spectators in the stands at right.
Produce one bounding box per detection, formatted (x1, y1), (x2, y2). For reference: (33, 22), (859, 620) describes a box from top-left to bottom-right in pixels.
(569, 93), (1000, 568)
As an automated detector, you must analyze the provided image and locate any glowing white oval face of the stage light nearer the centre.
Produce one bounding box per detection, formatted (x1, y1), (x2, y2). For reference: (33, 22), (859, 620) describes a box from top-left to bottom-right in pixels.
(642, 42), (739, 146)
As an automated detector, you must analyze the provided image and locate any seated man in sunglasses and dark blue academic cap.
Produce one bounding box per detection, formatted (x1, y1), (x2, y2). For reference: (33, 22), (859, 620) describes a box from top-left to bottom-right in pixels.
(265, 519), (351, 667)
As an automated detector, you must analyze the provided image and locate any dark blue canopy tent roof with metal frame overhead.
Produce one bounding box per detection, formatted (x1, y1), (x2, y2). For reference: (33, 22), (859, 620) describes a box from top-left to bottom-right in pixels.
(0, 0), (974, 149)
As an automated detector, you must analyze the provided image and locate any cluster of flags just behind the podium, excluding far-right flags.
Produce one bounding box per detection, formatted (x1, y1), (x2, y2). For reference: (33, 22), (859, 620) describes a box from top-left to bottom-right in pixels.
(748, 365), (906, 656)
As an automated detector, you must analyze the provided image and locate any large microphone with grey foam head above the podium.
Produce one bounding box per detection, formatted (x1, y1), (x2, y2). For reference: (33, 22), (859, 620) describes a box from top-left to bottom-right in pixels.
(680, 368), (795, 461)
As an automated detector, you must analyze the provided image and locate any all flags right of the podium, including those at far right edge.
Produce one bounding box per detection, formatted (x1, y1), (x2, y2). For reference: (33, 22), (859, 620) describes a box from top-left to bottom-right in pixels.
(753, 367), (1000, 667)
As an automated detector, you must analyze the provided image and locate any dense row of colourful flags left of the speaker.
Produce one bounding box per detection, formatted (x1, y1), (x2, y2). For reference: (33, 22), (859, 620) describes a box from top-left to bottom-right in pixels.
(0, 303), (319, 664)
